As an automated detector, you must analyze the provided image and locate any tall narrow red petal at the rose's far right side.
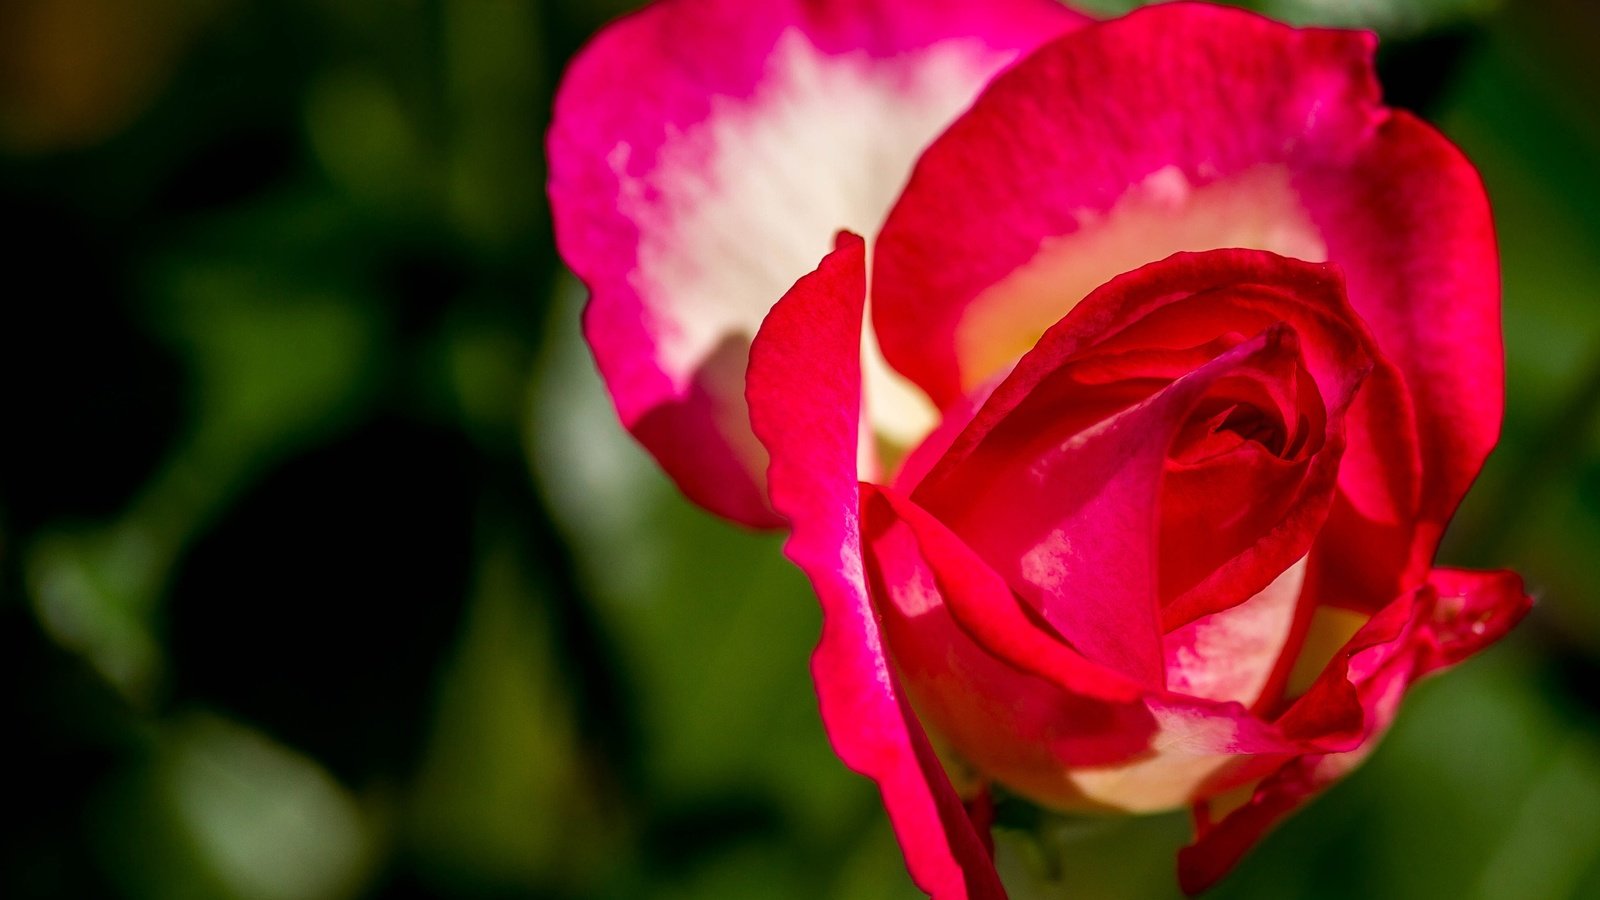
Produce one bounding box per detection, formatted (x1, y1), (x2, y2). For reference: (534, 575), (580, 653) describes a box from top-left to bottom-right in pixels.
(1301, 110), (1506, 533)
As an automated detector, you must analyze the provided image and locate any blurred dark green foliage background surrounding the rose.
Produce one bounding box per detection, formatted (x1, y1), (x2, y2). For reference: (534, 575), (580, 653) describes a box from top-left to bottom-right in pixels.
(0, 0), (1600, 900)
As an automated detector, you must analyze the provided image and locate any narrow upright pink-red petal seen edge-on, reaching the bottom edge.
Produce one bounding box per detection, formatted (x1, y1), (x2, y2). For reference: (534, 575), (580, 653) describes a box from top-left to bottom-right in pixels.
(749, 235), (1005, 900)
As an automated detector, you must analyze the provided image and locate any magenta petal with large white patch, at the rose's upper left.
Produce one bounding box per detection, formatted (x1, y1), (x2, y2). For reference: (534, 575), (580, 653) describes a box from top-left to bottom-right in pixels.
(549, 0), (1082, 525)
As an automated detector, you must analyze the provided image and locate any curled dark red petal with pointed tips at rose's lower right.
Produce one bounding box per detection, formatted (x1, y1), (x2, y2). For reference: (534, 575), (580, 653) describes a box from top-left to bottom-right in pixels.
(1178, 569), (1531, 894)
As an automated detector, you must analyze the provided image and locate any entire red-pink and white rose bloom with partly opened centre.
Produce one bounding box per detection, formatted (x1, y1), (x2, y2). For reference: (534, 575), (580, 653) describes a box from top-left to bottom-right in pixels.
(550, 0), (1526, 897)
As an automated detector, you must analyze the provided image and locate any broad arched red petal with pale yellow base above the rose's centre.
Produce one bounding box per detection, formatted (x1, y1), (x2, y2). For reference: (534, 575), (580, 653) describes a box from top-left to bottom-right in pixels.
(874, 3), (1382, 405)
